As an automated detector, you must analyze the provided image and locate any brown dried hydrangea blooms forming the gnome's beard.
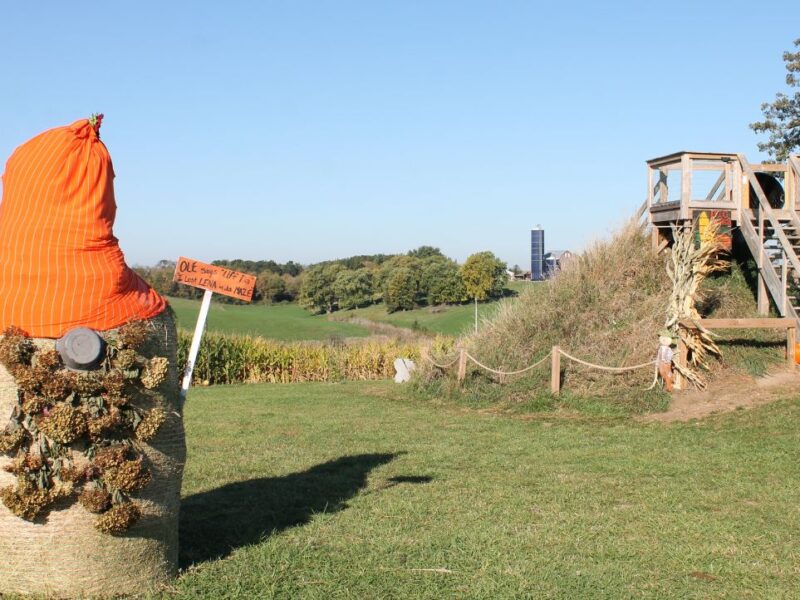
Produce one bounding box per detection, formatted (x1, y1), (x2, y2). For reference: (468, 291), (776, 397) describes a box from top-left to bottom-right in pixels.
(0, 316), (169, 534)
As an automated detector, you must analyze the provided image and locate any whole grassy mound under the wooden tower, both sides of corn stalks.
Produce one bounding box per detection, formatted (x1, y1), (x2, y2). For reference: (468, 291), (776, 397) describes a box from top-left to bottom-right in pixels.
(418, 223), (784, 411)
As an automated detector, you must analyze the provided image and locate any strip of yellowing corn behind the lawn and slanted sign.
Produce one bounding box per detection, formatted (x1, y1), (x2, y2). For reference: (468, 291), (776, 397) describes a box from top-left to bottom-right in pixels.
(178, 331), (420, 385)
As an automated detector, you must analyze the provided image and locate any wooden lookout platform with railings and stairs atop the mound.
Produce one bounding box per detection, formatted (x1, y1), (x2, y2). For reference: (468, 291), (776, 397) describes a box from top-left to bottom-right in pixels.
(642, 152), (800, 325)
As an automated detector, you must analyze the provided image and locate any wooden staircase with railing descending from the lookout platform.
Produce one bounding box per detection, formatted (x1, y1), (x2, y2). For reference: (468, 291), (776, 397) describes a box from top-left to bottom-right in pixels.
(738, 154), (800, 325)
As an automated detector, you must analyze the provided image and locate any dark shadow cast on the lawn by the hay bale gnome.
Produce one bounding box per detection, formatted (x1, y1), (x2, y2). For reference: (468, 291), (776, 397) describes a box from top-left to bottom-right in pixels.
(180, 454), (406, 567)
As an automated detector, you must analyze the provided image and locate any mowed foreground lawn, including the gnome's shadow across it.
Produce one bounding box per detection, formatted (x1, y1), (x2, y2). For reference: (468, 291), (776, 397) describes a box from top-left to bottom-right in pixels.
(169, 382), (800, 599)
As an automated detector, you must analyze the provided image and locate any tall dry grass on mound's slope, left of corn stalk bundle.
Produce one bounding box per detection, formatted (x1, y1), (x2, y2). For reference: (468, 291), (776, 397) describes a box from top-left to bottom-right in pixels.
(454, 223), (669, 395)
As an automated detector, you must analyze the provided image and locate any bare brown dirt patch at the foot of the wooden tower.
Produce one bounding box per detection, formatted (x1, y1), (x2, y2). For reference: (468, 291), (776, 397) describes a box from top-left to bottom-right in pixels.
(639, 371), (800, 423)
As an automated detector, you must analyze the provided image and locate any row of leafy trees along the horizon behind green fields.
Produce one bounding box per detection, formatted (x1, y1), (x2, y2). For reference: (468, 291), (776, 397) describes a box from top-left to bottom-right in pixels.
(135, 246), (507, 313)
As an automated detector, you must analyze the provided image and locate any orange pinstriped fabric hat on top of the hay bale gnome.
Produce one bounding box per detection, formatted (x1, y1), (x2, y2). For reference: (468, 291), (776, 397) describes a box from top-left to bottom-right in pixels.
(0, 119), (166, 338)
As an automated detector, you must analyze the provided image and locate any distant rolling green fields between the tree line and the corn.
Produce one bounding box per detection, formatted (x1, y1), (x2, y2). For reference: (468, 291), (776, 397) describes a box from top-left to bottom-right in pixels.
(169, 281), (530, 341)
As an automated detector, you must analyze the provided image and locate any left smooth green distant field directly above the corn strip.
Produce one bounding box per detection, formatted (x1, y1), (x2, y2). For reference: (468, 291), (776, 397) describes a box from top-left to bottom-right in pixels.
(169, 298), (369, 341)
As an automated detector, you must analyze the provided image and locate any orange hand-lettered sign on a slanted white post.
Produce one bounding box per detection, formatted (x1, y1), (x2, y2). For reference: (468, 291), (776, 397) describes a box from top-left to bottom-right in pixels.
(173, 256), (256, 400)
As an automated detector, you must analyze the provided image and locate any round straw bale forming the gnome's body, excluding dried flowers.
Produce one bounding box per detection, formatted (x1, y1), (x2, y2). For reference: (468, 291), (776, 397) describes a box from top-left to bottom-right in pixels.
(0, 312), (186, 597)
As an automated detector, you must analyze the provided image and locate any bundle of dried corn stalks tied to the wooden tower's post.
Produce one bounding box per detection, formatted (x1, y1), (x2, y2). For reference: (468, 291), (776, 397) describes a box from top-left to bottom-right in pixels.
(666, 219), (729, 389)
